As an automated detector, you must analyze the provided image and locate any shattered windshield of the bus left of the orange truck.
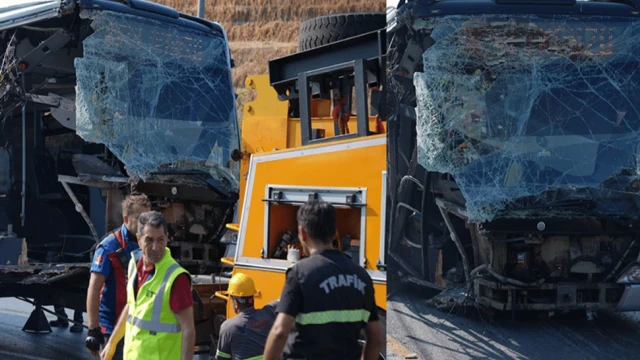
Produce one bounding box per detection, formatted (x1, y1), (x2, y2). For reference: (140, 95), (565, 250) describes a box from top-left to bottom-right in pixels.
(75, 11), (239, 188)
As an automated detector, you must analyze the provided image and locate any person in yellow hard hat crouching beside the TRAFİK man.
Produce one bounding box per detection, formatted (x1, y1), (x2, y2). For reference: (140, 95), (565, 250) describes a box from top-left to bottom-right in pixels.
(215, 273), (278, 360)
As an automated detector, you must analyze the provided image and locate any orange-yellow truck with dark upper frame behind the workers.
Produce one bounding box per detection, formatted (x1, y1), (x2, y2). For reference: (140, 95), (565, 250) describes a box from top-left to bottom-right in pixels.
(201, 14), (387, 358)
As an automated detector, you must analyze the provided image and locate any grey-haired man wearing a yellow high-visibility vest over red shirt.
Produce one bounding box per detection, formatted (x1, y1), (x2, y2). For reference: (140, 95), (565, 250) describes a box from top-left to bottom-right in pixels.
(100, 211), (196, 360)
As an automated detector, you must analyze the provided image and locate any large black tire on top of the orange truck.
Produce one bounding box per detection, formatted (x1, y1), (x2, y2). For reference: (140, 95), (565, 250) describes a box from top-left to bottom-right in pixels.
(298, 13), (387, 51)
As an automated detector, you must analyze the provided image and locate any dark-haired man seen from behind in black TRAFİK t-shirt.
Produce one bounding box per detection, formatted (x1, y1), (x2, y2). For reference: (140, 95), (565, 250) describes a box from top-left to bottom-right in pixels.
(264, 201), (383, 360)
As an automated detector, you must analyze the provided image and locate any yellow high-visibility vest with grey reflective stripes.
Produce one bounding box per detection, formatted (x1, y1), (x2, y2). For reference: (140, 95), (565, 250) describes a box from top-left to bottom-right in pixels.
(124, 249), (189, 360)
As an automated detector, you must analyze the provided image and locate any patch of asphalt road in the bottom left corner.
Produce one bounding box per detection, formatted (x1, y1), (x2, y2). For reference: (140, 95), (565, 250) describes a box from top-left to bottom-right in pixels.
(0, 298), (97, 360)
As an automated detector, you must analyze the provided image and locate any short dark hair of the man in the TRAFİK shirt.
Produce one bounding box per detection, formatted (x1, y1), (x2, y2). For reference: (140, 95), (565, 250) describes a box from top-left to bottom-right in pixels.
(298, 200), (336, 244)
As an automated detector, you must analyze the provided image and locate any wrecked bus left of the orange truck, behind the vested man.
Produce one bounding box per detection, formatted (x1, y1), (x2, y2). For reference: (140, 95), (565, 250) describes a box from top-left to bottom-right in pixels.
(0, 0), (239, 341)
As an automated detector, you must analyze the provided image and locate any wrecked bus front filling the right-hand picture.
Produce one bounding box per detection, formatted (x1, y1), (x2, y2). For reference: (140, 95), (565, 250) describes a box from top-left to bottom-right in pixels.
(387, 0), (640, 317)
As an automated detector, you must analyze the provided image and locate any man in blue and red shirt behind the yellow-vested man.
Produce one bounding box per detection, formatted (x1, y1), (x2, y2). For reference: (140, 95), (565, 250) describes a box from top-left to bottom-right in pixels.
(85, 195), (151, 360)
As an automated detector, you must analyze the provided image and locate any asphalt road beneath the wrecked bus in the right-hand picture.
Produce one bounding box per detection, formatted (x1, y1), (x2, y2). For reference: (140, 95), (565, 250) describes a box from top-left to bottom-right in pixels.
(387, 285), (640, 360)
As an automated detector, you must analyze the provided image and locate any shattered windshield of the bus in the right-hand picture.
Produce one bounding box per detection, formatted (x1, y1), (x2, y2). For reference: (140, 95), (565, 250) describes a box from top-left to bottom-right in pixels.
(414, 15), (640, 222)
